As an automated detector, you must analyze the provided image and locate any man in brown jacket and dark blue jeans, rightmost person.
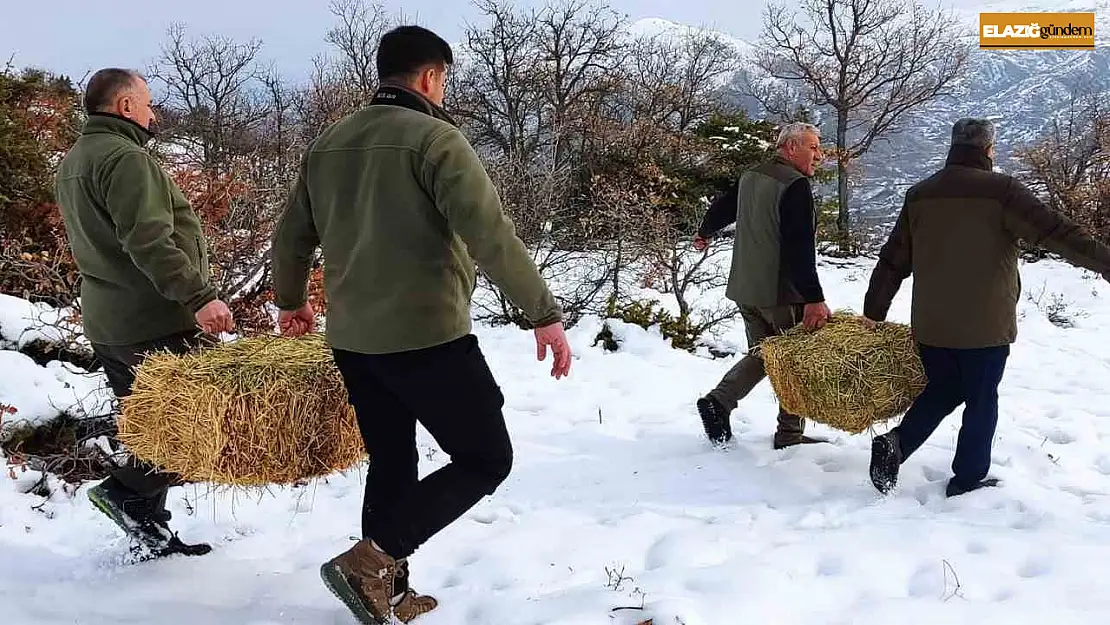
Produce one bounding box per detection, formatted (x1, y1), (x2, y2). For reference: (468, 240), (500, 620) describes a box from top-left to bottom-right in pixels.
(864, 119), (1110, 496)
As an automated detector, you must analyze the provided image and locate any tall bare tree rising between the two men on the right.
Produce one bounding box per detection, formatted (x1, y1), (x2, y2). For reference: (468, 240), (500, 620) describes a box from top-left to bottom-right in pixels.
(750, 0), (969, 242)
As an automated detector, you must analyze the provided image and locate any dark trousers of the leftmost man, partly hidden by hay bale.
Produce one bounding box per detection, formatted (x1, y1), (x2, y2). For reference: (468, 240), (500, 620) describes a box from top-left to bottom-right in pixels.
(92, 330), (214, 505)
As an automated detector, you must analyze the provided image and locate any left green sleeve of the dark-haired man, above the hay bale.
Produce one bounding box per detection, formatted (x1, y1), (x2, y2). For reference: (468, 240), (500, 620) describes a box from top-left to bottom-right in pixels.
(271, 150), (320, 311)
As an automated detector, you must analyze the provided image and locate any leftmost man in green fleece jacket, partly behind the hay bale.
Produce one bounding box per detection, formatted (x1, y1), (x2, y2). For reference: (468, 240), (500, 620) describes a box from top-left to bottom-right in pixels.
(56, 68), (233, 555)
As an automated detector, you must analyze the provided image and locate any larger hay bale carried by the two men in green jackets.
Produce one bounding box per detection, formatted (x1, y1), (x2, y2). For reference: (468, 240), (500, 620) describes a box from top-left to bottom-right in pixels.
(119, 334), (365, 486)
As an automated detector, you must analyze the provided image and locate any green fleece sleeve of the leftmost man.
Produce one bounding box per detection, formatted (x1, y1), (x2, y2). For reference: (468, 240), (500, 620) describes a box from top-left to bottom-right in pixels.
(102, 150), (218, 313)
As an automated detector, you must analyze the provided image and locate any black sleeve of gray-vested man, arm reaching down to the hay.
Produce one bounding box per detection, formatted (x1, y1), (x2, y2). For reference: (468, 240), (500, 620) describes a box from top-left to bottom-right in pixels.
(778, 178), (825, 304)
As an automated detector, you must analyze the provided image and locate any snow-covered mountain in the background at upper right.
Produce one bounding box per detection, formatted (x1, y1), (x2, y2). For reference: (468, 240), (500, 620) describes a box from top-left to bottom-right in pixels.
(633, 0), (1110, 222)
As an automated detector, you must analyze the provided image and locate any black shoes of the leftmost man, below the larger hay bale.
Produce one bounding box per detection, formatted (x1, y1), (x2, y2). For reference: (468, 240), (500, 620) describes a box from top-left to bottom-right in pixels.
(89, 478), (212, 557)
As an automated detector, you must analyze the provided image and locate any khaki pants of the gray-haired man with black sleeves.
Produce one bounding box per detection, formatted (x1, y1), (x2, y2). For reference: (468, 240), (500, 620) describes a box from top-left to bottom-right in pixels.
(709, 304), (806, 442)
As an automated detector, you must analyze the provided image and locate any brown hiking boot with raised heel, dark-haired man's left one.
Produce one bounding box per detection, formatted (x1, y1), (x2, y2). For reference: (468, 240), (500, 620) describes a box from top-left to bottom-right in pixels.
(320, 538), (396, 625)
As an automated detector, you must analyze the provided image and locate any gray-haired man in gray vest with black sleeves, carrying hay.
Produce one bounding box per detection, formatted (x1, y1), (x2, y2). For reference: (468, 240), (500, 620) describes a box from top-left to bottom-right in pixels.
(694, 122), (829, 450)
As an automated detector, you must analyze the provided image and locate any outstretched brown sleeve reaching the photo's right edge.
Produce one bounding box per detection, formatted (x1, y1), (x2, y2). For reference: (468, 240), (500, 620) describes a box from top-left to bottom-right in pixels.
(1002, 180), (1110, 275)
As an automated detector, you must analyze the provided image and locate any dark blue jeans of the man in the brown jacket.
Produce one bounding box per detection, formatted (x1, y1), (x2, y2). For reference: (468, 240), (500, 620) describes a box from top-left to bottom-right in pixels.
(895, 345), (1010, 485)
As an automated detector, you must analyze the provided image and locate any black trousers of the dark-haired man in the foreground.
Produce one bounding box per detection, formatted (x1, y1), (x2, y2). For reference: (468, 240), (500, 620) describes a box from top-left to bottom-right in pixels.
(334, 335), (513, 558)
